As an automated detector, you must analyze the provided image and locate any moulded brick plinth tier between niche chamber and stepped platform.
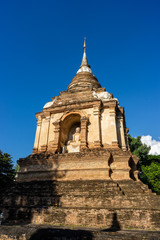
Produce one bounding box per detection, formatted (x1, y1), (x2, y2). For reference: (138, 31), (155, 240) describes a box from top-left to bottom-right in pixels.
(17, 148), (136, 182)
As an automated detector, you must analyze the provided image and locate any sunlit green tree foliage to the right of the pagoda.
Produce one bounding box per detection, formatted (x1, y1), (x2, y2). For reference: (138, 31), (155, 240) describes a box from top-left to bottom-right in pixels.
(128, 135), (160, 194)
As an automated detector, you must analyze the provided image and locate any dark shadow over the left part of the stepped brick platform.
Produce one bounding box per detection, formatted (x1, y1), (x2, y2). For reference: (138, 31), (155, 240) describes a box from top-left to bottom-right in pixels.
(0, 181), (61, 224)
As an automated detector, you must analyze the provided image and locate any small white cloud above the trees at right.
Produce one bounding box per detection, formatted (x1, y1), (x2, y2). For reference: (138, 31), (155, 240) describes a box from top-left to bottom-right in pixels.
(141, 135), (160, 155)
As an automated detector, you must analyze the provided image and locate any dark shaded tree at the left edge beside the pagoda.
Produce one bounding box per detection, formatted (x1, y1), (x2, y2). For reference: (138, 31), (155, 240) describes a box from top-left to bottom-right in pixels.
(0, 150), (16, 188)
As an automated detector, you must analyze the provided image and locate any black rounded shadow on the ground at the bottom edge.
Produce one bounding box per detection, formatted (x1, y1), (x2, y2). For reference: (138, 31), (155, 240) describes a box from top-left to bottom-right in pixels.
(29, 228), (93, 240)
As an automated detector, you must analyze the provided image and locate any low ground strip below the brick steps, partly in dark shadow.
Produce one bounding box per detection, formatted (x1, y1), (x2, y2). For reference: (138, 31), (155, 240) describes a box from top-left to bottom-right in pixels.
(0, 224), (160, 240)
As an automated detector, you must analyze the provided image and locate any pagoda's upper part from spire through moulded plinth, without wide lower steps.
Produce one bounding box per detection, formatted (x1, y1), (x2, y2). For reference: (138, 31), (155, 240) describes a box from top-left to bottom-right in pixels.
(17, 39), (137, 181)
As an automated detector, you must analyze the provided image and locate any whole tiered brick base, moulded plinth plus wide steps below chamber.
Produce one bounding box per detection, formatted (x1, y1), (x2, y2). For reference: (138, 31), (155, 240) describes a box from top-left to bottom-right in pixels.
(0, 150), (160, 230)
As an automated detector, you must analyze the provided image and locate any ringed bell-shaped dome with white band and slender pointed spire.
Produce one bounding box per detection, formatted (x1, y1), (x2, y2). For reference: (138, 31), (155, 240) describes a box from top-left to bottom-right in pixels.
(68, 40), (101, 92)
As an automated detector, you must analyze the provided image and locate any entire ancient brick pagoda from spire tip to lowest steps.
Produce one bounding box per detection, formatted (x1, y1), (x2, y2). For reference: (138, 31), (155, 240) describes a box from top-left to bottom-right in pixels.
(0, 42), (160, 230)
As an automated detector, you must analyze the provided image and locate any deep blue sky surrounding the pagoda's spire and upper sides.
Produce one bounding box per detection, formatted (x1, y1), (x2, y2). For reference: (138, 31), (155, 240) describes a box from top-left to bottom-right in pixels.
(0, 0), (160, 161)
